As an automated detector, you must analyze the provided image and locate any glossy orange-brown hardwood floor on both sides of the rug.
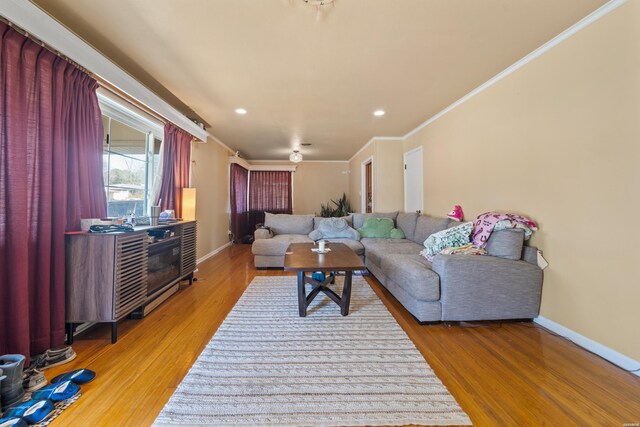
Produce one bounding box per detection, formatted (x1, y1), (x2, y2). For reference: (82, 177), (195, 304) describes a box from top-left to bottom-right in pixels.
(45, 245), (640, 426)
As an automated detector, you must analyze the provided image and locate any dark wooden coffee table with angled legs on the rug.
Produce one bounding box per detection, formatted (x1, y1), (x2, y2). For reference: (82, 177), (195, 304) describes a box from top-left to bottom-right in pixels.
(284, 243), (365, 317)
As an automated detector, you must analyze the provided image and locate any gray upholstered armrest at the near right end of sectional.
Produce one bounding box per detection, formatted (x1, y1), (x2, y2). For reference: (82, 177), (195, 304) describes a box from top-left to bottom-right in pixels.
(432, 255), (542, 320)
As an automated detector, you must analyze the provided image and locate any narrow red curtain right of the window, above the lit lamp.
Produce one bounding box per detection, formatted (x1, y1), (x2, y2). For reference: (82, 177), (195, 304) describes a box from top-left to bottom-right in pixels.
(156, 123), (192, 218)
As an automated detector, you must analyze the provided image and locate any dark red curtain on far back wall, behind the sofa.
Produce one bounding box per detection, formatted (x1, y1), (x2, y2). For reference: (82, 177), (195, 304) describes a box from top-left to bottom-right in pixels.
(249, 171), (292, 230)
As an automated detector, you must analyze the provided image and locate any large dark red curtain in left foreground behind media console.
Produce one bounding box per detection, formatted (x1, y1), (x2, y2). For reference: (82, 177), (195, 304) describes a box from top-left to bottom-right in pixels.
(0, 22), (106, 356)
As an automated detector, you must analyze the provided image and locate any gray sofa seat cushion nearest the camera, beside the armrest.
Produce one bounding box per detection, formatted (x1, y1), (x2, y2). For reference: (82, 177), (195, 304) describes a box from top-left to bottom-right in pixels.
(380, 254), (440, 301)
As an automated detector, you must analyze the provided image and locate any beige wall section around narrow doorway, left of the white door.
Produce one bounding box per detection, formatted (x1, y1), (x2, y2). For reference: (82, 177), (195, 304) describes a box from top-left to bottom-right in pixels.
(349, 138), (404, 212)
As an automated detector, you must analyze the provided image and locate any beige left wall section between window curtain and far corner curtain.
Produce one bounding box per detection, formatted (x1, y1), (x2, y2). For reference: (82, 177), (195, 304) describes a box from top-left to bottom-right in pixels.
(191, 140), (232, 258)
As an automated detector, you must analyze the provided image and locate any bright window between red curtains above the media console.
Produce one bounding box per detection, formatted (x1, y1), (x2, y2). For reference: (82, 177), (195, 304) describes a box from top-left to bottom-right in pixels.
(102, 115), (162, 217)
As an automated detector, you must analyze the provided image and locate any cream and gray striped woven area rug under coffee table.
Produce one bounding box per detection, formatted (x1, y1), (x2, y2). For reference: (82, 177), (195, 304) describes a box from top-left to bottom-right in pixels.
(155, 276), (471, 426)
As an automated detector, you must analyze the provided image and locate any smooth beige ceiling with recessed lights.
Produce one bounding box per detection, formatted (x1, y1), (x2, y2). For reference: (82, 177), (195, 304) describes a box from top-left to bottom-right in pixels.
(33, 0), (606, 160)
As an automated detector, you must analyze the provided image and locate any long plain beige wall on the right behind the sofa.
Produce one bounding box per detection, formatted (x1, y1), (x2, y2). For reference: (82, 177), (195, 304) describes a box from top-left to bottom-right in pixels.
(404, 2), (640, 360)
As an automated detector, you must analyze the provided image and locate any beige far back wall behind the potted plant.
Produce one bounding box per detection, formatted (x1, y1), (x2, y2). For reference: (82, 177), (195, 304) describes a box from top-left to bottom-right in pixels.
(249, 160), (353, 214)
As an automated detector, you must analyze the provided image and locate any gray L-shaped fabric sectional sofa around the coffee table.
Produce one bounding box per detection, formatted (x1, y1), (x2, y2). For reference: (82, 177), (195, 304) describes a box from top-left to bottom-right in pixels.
(252, 212), (542, 322)
